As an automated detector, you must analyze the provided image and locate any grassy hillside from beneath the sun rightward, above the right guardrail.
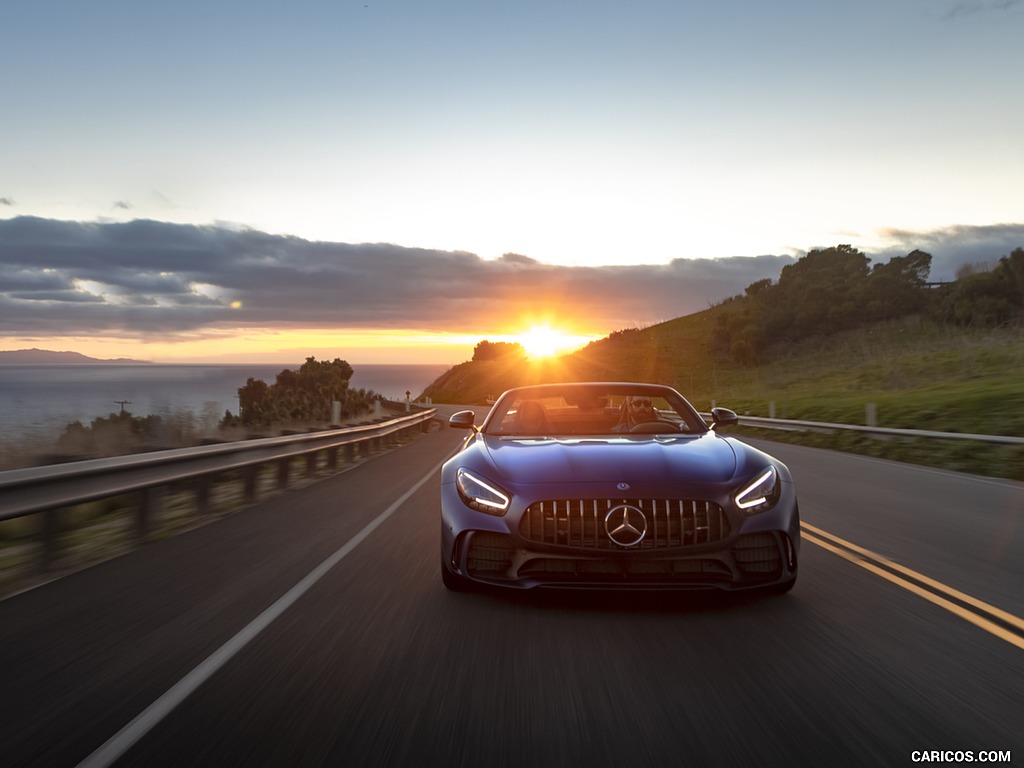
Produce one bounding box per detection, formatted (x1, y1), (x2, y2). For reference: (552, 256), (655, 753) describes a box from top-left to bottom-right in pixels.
(425, 308), (1024, 435)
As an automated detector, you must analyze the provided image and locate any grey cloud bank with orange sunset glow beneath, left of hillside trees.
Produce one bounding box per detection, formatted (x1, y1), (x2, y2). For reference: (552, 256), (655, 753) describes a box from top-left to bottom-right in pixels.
(0, 218), (792, 362)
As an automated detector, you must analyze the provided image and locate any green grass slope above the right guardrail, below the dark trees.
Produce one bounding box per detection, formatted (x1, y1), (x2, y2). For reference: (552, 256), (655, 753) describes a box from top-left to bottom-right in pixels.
(675, 324), (1024, 428)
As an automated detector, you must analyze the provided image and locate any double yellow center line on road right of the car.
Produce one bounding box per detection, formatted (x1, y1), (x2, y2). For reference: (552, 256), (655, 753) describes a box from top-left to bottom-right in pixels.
(800, 522), (1024, 650)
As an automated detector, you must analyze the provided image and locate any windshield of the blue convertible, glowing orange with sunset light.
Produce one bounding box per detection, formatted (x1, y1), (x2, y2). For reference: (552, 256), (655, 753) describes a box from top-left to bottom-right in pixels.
(483, 384), (708, 437)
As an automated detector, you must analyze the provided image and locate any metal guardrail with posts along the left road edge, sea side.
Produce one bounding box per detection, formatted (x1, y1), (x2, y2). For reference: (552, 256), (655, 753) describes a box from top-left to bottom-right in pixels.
(0, 410), (435, 520)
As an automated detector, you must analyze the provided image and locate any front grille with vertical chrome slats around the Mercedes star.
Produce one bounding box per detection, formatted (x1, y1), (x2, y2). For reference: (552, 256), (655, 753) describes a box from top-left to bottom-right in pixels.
(519, 499), (729, 551)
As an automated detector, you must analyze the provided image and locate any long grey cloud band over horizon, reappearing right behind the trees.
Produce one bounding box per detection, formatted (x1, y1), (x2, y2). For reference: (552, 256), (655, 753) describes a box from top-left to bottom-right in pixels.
(0, 217), (1024, 339)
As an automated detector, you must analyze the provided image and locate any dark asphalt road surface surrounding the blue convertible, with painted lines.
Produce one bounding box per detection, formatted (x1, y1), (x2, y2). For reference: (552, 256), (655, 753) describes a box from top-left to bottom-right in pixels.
(0, 415), (1024, 767)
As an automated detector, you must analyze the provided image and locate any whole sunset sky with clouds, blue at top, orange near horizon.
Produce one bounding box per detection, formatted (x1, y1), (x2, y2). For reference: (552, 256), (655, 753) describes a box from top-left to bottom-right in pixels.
(0, 0), (1024, 362)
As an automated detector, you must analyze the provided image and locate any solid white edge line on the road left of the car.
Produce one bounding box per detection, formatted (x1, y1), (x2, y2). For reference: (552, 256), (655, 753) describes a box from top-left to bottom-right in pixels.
(78, 462), (443, 768)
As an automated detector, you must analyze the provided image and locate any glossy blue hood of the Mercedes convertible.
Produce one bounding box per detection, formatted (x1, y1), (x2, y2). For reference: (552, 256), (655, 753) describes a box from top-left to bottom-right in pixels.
(485, 432), (736, 483)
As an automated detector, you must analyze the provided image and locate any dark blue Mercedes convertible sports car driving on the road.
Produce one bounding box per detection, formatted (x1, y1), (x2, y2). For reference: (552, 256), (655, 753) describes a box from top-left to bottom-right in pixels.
(441, 383), (800, 592)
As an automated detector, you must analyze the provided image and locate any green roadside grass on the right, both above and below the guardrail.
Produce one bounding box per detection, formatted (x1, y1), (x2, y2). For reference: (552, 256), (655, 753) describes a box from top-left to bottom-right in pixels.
(679, 323), (1024, 480)
